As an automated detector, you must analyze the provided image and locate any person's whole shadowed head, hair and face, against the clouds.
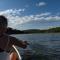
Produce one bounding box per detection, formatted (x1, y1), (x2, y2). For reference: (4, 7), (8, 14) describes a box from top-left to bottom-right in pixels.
(0, 15), (8, 34)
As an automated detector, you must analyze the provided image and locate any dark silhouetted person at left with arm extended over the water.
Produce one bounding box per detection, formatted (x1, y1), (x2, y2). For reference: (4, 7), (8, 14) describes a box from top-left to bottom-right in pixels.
(0, 15), (28, 60)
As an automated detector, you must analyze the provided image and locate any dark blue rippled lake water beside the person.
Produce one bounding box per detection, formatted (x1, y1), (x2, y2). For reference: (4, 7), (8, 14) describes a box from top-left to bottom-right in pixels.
(13, 33), (60, 60)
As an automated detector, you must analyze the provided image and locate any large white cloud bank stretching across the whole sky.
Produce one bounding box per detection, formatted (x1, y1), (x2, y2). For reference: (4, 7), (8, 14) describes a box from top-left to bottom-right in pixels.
(0, 9), (60, 28)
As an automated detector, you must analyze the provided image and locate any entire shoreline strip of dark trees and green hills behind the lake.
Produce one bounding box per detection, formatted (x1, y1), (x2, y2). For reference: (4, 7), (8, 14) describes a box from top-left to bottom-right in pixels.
(6, 27), (60, 34)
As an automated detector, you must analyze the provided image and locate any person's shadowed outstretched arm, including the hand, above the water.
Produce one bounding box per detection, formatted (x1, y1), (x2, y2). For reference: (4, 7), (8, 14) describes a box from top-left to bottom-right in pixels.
(10, 37), (28, 48)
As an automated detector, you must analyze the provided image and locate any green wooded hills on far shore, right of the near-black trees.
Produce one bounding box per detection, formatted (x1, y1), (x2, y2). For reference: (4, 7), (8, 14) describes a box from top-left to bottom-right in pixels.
(24, 27), (60, 33)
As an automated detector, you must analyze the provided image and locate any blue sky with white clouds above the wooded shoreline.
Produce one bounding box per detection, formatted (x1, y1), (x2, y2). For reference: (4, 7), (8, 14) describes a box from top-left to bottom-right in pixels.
(0, 0), (60, 30)
